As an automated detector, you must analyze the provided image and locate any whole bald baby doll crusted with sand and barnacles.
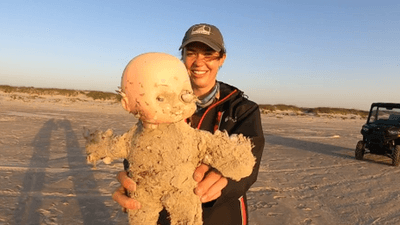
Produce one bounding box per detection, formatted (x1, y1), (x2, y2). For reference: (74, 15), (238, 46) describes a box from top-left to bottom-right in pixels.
(85, 53), (255, 225)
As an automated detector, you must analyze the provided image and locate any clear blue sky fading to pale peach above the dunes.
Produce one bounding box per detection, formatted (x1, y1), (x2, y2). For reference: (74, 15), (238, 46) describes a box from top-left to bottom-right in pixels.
(0, 0), (400, 110)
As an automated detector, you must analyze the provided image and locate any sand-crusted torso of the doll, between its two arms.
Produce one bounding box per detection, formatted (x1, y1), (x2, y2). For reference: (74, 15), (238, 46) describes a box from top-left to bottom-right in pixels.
(127, 122), (201, 192)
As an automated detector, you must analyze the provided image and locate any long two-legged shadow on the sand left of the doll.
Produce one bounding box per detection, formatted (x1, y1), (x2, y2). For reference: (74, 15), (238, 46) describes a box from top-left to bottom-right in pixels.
(14, 119), (115, 224)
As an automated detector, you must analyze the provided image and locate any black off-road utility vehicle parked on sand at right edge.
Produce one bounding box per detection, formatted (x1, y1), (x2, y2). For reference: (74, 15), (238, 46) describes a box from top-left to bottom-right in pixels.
(355, 103), (400, 166)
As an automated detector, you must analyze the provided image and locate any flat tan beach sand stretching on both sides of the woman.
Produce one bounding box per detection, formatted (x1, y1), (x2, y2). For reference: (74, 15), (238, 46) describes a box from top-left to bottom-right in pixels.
(0, 92), (400, 225)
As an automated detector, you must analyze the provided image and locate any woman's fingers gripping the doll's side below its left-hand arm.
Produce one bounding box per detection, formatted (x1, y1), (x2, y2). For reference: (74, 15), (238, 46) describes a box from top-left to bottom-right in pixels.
(112, 171), (141, 211)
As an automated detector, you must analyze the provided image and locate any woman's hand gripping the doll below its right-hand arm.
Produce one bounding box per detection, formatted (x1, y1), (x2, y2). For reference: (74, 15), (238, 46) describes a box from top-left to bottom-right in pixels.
(193, 164), (228, 203)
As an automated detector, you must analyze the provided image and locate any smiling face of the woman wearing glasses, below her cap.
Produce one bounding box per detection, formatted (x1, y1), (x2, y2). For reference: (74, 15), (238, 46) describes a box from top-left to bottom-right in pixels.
(183, 42), (226, 97)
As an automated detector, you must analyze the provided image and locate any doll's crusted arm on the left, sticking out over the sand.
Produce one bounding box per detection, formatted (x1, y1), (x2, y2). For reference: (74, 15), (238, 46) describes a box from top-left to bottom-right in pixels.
(83, 126), (136, 166)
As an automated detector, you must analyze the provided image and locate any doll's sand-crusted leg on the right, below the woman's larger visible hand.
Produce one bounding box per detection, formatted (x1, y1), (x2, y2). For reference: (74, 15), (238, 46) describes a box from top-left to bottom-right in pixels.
(164, 191), (203, 225)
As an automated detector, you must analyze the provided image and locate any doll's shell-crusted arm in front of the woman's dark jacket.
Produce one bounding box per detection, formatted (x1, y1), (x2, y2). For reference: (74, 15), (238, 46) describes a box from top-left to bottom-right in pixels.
(203, 130), (255, 181)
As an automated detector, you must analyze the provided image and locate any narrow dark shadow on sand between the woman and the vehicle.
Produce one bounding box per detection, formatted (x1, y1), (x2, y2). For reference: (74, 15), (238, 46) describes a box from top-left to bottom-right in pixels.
(265, 134), (354, 159)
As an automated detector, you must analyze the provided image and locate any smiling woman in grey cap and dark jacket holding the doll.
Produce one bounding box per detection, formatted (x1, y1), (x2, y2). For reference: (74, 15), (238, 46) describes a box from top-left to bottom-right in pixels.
(113, 24), (264, 225)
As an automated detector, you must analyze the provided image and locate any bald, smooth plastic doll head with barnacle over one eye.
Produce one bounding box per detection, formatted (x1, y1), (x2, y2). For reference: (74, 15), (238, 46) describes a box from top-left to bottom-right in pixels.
(121, 53), (197, 124)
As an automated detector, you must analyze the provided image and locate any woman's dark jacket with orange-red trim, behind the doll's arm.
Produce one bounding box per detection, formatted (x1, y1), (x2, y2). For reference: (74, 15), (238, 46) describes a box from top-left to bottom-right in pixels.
(192, 82), (265, 225)
